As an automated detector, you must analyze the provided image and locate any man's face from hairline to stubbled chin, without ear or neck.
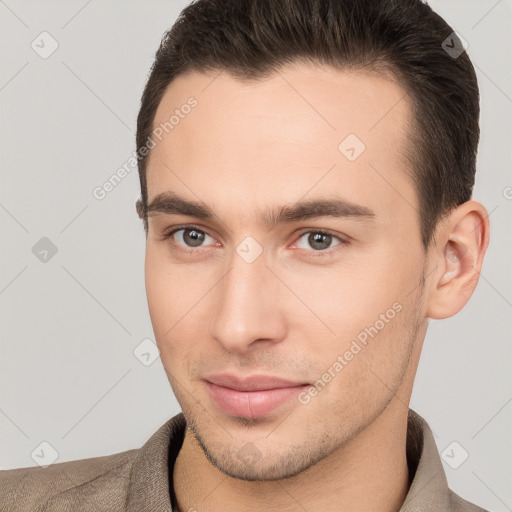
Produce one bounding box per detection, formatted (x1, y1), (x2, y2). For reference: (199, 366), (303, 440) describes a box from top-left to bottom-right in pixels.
(145, 65), (426, 479)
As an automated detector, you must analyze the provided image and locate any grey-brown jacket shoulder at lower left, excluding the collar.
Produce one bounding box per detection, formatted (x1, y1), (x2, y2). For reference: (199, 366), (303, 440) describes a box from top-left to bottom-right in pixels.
(0, 449), (139, 512)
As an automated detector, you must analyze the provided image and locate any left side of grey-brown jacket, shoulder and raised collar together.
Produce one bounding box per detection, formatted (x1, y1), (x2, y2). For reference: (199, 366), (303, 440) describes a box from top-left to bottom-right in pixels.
(0, 413), (186, 512)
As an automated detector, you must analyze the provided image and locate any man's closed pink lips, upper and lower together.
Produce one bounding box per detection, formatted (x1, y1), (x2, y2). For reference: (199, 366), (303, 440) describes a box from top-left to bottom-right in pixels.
(204, 374), (309, 418)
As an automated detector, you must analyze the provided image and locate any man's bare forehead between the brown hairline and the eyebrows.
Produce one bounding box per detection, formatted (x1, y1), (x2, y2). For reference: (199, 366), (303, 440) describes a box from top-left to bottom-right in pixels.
(147, 64), (416, 224)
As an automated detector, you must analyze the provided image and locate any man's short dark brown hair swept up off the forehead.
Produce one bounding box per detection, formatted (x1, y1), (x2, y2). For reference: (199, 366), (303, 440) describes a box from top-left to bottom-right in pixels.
(136, 0), (480, 248)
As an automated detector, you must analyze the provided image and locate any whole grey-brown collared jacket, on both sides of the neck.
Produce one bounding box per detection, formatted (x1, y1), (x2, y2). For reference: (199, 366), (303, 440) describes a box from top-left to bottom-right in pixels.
(0, 409), (486, 512)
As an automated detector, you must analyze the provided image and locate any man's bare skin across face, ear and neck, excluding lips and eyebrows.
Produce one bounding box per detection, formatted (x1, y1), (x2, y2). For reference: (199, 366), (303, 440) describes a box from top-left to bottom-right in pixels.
(138, 64), (489, 512)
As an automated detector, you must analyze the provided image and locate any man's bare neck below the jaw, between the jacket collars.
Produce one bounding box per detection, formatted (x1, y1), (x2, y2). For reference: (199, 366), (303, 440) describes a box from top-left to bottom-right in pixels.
(173, 397), (409, 512)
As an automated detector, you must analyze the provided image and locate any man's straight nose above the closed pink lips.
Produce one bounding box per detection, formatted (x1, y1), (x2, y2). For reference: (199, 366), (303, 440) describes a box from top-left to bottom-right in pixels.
(210, 247), (286, 353)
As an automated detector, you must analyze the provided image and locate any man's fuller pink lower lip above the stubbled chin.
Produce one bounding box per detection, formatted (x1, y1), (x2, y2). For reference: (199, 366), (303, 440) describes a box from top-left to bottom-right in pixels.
(206, 382), (308, 418)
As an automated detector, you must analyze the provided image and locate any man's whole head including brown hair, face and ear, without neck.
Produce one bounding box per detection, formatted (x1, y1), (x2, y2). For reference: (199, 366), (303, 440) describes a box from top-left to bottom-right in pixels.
(137, 0), (489, 480)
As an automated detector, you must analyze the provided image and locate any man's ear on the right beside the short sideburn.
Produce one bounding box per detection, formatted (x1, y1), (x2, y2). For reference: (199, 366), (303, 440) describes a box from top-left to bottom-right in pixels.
(426, 200), (490, 319)
